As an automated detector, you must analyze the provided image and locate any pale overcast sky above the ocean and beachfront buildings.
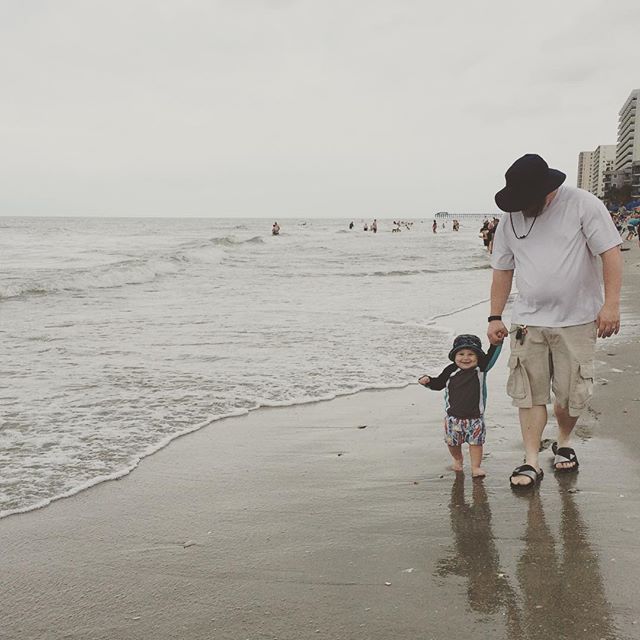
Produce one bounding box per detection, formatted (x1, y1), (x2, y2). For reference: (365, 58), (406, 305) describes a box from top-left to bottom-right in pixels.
(0, 0), (640, 219)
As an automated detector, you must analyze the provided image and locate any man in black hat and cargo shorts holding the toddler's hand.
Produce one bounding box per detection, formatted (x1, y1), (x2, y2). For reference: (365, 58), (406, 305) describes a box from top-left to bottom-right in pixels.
(487, 154), (622, 489)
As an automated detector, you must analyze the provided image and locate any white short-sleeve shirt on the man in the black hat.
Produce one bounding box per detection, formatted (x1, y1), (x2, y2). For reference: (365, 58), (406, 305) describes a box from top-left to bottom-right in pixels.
(491, 185), (621, 327)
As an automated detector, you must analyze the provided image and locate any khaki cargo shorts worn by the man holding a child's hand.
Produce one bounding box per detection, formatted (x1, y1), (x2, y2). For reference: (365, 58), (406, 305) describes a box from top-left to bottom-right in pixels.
(507, 322), (597, 418)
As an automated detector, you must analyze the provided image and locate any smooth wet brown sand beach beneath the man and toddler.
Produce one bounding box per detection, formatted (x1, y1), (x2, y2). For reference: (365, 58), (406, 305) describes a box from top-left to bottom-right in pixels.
(0, 245), (640, 640)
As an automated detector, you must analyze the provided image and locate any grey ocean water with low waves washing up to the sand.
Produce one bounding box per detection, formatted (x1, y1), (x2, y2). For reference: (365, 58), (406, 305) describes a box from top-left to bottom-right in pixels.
(0, 218), (491, 517)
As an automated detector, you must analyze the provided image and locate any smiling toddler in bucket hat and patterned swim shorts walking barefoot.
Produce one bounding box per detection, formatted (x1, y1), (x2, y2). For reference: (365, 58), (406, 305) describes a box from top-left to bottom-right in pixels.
(418, 334), (502, 478)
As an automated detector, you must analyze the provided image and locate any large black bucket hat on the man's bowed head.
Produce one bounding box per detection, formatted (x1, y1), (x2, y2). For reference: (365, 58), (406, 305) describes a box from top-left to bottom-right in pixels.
(495, 153), (567, 212)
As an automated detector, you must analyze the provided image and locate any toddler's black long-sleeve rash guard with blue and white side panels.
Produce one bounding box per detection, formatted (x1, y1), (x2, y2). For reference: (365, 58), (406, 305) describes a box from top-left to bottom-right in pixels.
(425, 344), (502, 419)
